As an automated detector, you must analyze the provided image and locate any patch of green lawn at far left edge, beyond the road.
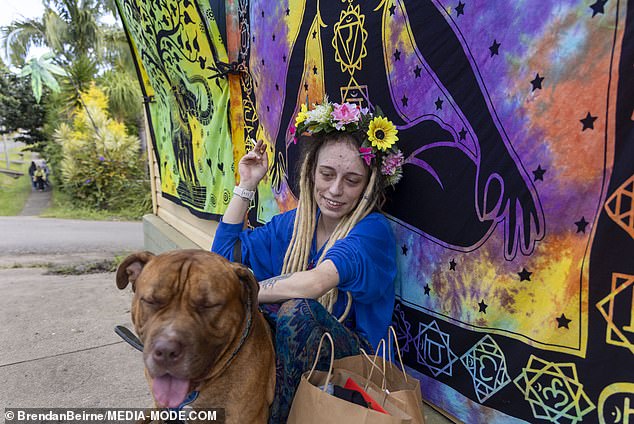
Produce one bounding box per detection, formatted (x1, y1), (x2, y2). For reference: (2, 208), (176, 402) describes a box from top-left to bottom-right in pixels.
(0, 149), (31, 216)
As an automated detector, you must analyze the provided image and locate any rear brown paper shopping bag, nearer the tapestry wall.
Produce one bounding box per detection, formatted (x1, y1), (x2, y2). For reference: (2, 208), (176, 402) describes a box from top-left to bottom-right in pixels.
(334, 327), (425, 424)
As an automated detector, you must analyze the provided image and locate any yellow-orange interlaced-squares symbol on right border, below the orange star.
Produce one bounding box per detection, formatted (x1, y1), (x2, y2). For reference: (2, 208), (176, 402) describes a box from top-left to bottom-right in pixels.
(597, 272), (634, 353)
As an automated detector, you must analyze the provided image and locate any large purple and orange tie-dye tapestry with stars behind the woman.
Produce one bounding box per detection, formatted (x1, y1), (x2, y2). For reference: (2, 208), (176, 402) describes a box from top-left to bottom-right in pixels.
(227, 0), (634, 423)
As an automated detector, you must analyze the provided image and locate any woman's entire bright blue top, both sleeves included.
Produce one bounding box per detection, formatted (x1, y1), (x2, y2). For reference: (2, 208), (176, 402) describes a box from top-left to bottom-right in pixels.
(211, 209), (396, 348)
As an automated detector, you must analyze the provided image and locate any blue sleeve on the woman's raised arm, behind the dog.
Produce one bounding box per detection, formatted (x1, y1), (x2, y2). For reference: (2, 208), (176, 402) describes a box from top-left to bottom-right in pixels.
(211, 210), (295, 281)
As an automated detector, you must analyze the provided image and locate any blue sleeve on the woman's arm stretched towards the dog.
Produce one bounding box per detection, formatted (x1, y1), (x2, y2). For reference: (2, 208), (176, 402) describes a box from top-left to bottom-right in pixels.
(324, 213), (396, 304)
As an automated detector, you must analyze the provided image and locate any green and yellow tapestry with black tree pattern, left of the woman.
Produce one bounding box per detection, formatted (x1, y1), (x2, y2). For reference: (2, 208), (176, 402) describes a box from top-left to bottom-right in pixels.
(117, 0), (235, 217)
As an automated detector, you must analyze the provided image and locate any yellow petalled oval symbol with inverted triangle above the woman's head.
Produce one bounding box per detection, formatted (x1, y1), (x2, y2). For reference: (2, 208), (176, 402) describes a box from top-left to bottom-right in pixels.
(332, 4), (368, 75)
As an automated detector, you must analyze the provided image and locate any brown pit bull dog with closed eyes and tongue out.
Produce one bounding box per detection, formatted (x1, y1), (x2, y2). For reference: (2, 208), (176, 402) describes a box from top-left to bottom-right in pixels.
(117, 250), (275, 424)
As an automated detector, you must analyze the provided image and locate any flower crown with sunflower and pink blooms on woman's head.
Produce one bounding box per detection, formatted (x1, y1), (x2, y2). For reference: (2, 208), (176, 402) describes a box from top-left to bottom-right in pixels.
(291, 98), (404, 186)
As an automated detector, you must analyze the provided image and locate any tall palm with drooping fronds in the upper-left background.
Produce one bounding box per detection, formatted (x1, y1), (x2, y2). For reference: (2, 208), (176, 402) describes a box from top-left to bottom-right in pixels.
(3, 0), (142, 124)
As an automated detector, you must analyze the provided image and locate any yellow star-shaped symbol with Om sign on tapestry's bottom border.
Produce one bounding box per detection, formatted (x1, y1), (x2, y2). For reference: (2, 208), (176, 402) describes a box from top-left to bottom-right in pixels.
(513, 355), (595, 424)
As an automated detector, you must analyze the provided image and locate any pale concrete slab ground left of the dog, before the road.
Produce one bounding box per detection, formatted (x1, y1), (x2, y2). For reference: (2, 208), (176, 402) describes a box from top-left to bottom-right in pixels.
(0, 268), (152, 408)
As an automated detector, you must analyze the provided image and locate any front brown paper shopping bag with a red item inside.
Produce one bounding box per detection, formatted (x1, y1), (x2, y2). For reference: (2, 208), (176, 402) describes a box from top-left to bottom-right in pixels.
(287, 333), (413, 424)
